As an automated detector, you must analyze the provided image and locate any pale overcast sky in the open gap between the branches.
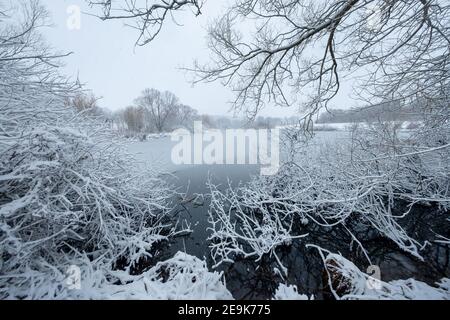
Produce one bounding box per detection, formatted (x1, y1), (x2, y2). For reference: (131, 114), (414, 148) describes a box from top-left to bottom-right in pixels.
(41, 0), (356, 116)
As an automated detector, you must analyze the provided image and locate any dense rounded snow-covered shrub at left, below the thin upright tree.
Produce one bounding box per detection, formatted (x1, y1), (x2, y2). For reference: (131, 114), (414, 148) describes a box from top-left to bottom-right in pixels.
(0, 127), (172, 280)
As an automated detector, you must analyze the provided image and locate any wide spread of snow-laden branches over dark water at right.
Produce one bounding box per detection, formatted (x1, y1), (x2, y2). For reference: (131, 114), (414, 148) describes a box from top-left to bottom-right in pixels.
(210, 120), (450, 270)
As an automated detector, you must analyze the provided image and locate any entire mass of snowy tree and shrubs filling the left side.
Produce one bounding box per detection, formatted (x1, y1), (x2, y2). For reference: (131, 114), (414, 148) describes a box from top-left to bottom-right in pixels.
(0, 1), (181, 298)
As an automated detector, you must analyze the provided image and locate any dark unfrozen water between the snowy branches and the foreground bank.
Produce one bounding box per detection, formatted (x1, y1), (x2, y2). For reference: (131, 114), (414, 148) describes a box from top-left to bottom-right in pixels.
(158, 165), (450, 299)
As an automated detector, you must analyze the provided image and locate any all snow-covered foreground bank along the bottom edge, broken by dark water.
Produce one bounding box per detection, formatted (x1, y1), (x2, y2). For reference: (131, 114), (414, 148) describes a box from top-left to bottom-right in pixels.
(8, 249), (450, 300)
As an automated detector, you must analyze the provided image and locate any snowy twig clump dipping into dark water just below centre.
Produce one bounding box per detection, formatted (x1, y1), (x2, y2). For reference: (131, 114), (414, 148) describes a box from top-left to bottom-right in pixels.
(209, 178), (306, 272)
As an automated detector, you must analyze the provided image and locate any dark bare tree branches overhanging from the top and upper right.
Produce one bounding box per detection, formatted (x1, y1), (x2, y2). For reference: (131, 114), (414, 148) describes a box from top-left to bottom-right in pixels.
(89, 0), (450, 127)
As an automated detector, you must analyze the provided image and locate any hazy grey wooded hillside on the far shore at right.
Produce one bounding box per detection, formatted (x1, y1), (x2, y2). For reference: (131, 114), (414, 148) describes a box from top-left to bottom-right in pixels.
(317, 102), (421, 123)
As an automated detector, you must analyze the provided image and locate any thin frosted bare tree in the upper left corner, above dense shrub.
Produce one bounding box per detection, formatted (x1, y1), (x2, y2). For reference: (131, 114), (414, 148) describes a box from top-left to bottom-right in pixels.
(0, 1), (78, 139)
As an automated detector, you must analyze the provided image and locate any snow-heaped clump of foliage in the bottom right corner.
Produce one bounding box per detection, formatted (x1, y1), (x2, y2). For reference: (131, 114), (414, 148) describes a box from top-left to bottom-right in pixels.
(317, 248), (450, 300)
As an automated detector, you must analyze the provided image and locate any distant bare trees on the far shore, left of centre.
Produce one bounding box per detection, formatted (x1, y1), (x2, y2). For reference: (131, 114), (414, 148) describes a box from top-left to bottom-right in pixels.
(67, 89), (292, 139)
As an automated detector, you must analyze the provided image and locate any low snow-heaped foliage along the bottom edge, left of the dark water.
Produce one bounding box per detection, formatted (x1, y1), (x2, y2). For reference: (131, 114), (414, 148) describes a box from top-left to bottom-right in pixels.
(4, 252), (233, 300)
